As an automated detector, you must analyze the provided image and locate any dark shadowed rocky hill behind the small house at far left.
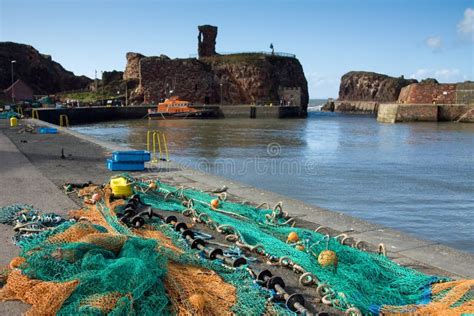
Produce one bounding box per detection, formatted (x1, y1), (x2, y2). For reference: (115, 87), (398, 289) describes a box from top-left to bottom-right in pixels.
(0, 42), (92, 94)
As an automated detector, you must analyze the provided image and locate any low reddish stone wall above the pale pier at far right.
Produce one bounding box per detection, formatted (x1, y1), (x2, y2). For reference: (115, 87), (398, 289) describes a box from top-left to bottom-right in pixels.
(398, 83), (456, 104)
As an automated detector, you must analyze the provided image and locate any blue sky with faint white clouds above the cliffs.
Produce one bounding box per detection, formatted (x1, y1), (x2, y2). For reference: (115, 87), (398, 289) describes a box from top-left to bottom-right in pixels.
(0, 0), (474, 98)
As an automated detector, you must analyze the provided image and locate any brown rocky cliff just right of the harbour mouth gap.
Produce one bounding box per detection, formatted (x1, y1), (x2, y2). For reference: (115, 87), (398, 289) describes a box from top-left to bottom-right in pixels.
(339, 71), (418, 102)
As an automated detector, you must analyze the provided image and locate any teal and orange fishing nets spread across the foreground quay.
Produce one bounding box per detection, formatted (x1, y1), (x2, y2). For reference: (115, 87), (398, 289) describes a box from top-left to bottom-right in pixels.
(0, 175), (474, 315)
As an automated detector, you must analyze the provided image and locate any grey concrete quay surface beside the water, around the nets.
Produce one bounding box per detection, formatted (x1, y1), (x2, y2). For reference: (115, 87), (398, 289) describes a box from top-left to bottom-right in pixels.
(0, 120), (474, 315)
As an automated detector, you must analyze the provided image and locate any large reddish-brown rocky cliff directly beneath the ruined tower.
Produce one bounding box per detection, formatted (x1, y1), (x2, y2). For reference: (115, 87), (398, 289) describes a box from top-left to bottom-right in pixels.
(124, 53), (308, 111)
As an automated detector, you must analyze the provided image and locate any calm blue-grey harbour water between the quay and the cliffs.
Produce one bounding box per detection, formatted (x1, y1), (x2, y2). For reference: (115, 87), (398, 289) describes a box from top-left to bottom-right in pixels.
(74, 113), (474, 252)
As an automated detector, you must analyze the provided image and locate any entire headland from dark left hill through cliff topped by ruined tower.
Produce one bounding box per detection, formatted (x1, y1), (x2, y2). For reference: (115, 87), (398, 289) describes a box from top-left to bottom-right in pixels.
(0, 25), (309, 116)
